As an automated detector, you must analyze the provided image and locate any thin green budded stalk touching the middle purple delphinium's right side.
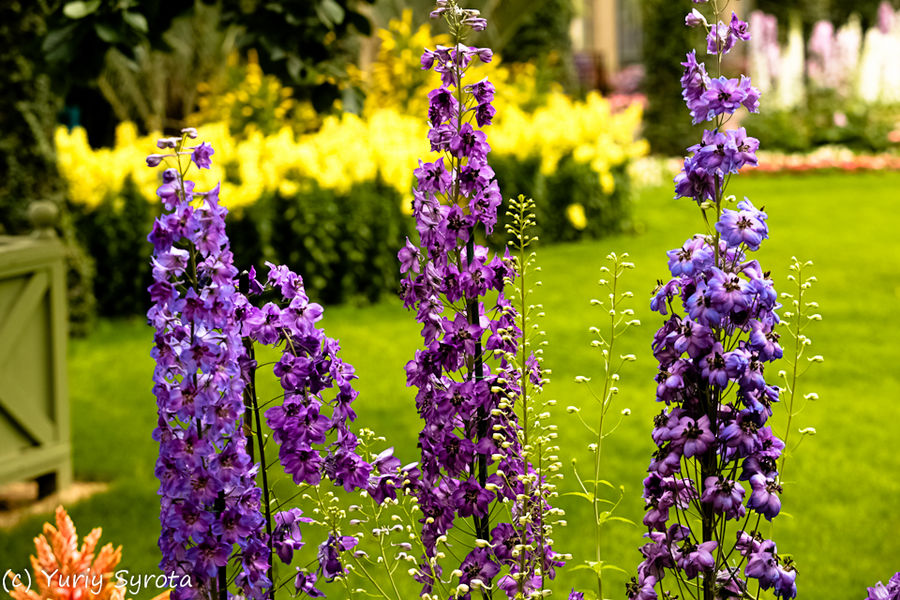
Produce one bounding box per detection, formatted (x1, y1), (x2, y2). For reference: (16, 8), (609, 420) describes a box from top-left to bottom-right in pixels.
(495, 195), (565, 598)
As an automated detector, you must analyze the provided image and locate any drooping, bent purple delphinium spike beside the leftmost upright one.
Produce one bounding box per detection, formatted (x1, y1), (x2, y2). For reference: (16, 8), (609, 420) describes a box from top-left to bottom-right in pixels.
(239, 263), (372, 597)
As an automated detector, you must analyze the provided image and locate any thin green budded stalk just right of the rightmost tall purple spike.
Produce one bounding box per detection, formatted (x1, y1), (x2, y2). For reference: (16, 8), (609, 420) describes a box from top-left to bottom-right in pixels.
(778, 257), (825, 485)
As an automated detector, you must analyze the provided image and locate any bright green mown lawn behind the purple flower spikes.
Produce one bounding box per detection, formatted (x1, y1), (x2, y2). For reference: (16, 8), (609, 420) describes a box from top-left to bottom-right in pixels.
(0, 173), (900, 600)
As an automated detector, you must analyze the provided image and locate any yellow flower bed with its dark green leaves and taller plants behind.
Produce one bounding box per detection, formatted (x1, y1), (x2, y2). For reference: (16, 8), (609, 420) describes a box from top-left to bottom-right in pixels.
(45, 3), (646, 315)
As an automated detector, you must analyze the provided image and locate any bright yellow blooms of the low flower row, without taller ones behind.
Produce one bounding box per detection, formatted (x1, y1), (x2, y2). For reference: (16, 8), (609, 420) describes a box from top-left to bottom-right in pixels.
(56, 93), (647, 207)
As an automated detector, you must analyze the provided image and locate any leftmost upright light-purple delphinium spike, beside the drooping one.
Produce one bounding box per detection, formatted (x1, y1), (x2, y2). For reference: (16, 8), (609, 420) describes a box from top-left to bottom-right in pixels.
(147, 130), (271, 599)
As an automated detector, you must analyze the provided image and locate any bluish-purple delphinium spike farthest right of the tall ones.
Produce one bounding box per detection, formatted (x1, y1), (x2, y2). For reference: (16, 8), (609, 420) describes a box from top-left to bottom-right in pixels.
(628, 4), (797, 600)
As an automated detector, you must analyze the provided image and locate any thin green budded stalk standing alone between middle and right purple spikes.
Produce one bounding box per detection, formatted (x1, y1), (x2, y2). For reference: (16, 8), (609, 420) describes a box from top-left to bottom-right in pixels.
(566, 252), (640, 600)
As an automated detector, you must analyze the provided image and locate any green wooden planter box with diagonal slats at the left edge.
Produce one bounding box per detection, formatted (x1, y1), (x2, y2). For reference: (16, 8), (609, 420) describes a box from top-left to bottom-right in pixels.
(0, 206), (72, 496)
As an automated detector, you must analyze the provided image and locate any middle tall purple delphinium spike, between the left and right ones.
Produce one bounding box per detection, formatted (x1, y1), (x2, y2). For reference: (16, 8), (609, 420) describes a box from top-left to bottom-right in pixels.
(399, 0), (561, 599)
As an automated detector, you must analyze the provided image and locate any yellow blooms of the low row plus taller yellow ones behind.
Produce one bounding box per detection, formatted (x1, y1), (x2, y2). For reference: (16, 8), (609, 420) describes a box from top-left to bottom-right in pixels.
(56, 14), (647, 208)
